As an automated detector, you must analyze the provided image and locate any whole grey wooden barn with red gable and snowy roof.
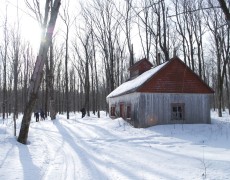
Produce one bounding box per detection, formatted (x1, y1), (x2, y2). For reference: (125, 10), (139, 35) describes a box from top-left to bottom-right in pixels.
(107, 57), (214, 128)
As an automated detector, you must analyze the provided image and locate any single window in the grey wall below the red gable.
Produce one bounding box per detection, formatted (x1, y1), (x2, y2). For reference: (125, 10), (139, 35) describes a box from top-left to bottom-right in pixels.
(171, 103), (184, 120)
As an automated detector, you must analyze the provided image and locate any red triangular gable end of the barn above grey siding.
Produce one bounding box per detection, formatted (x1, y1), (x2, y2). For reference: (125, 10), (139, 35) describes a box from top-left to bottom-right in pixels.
(136, 57), (214, 94)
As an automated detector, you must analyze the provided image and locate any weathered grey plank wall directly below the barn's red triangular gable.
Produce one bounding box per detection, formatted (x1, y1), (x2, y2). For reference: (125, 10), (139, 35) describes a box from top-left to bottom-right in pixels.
(136, 93), (211, 127)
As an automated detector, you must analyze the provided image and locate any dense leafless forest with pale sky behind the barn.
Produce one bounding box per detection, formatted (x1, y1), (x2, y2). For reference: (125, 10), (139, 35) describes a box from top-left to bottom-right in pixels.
(0, 0), (230, 122)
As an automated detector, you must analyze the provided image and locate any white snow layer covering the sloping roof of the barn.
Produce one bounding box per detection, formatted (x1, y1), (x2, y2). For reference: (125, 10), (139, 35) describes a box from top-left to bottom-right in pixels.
(107, 61), (169, 98)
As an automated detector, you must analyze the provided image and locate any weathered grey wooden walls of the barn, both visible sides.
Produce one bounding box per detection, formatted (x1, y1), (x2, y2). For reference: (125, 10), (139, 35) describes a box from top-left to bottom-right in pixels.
(109, 93), (211, 128)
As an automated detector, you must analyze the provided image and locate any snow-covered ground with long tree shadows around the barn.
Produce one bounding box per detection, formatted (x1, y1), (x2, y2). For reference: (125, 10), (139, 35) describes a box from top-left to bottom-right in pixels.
(0, 109), (230, 180)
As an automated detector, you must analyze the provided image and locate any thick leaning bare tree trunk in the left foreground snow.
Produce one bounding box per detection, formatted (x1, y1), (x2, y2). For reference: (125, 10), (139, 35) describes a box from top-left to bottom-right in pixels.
(18, 0), (61, 144)
